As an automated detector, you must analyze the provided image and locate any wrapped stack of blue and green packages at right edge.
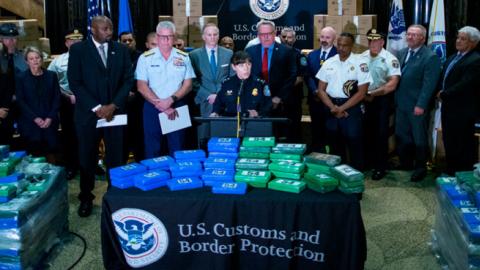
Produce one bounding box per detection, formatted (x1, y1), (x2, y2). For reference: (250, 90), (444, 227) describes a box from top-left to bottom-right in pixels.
(431, 163), (480, 269)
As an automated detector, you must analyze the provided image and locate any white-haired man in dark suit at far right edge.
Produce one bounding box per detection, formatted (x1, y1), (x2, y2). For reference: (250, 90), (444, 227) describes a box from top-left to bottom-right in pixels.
(439, 26), (480, 175)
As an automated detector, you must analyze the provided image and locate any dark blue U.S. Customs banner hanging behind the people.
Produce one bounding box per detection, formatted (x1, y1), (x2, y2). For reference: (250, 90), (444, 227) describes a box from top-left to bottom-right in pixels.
(203, 0), (327, 49)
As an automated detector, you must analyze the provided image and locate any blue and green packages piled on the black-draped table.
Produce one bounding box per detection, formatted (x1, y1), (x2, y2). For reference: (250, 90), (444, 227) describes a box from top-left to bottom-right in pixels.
(110, 137), (365, 194)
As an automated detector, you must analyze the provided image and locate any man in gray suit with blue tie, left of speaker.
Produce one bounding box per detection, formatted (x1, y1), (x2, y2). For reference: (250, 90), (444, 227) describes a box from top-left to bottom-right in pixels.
(189, 23), (233, 146)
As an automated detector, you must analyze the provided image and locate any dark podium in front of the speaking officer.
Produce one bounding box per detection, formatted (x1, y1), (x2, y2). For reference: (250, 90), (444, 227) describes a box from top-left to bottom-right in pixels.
(193, 117), (289, 137)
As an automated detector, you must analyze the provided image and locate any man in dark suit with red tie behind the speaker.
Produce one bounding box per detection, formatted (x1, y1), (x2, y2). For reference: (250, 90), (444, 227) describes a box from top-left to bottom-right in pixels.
(246, 20), (297, 139)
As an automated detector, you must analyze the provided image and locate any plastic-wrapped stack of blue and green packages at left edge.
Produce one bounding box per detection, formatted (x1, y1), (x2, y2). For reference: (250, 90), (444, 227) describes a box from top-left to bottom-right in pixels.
(0, 146), (68, 269)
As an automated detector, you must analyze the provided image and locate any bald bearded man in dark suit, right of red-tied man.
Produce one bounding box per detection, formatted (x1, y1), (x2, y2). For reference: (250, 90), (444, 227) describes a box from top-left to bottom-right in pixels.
(305, 26), (337, 153)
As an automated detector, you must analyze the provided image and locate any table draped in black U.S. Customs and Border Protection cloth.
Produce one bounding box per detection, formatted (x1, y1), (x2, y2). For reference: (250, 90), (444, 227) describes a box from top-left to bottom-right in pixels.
(101, 187), (366, 270)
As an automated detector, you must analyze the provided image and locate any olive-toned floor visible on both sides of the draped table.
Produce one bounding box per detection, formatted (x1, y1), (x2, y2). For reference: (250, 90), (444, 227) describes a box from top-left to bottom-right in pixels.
(41, 171), (440, 270)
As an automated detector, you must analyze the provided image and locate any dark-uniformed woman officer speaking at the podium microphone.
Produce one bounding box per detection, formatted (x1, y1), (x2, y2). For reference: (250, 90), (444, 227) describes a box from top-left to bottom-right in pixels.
(210, 51), (272, 117)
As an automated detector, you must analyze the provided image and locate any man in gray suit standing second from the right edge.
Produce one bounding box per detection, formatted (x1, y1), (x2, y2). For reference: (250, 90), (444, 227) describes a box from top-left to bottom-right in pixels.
(395, 25), (440, 182)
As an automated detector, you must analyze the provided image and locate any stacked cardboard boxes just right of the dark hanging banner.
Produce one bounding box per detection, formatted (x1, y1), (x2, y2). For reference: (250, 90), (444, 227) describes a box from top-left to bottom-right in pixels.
(313, 0), (377, 53)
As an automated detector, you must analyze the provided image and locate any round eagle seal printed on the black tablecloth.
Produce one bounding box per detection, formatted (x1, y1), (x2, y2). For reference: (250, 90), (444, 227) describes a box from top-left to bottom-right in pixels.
(112, 208), (168, 268)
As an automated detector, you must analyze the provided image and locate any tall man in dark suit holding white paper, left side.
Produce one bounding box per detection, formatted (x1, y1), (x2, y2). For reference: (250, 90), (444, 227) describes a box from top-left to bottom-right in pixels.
(68, 16), (133, 217)
